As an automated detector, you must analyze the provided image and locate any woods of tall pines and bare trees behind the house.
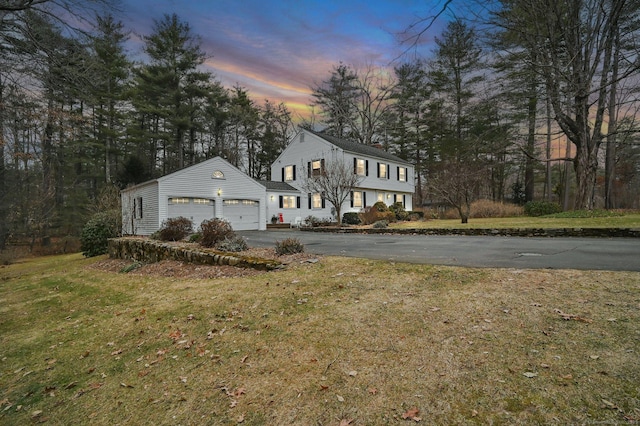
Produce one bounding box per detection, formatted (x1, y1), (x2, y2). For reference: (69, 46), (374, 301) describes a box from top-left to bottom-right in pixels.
(0, 0), (640, 249)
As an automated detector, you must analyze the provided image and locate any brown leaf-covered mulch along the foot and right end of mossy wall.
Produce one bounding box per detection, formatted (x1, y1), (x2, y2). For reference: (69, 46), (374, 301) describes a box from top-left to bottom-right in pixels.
(88, 248), (319, 279)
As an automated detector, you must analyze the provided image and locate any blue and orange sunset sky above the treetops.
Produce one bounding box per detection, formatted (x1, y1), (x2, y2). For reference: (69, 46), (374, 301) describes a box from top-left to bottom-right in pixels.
(118, 0), (450, 119)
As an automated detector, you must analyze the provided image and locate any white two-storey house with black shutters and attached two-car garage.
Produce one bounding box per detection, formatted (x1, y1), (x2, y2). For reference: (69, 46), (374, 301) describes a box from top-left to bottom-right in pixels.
(121, 130), (415, 235)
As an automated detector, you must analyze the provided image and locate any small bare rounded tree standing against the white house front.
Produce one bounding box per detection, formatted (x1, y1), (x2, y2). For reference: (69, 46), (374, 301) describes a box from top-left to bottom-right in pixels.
(302, 158), (363, 226)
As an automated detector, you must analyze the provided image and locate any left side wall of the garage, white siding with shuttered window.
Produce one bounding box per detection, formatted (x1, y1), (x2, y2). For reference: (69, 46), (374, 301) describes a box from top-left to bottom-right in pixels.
(120, 180), (159, 235)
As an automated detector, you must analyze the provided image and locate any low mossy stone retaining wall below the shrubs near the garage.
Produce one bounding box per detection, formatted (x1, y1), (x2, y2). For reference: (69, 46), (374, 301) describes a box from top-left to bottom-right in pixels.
(109, 238), (283, 271)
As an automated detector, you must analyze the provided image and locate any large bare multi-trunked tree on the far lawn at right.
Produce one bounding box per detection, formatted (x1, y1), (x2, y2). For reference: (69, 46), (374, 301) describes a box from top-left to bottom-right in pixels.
(496, 0), (640, 209)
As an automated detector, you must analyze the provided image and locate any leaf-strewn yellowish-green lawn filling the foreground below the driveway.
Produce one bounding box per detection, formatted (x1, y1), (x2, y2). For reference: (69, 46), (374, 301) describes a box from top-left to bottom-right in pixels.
(0, 255), (640, 425)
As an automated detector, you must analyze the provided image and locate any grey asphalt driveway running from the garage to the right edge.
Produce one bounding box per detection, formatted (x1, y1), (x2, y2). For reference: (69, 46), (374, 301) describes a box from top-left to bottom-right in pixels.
(238, 230), (640, 272)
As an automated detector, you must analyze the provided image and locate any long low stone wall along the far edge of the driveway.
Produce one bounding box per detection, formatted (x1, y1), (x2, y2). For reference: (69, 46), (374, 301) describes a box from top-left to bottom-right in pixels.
(301, 227), (640, 238)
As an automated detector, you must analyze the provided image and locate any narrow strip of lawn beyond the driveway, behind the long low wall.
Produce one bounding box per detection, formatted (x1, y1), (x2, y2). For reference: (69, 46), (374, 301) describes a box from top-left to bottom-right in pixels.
(389, 212), (640, 229)
